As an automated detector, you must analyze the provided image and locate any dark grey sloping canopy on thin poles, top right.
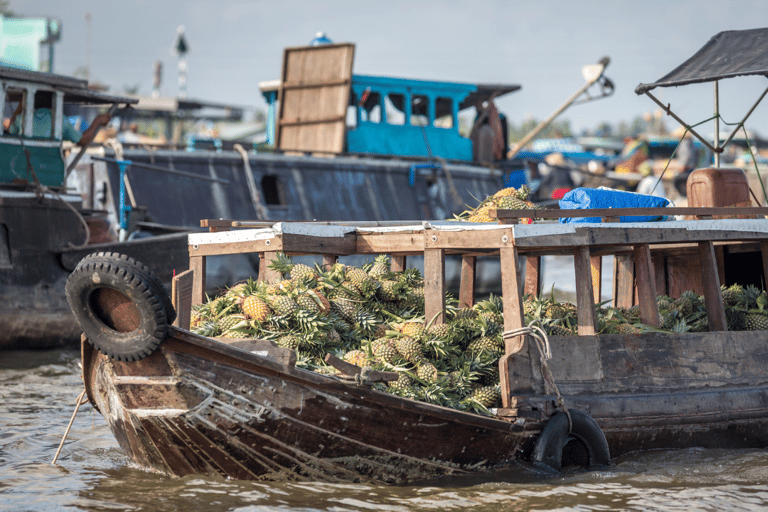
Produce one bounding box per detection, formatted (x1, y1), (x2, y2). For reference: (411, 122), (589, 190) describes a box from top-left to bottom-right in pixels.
(635, 28), (768, 94)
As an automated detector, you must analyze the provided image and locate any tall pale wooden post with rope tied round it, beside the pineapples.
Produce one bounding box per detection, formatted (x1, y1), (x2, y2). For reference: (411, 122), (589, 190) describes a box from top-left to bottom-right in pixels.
(499, 246), (525, 408)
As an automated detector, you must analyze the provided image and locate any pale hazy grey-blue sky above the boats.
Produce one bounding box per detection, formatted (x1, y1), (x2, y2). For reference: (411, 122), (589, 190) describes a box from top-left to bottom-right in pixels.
(10, 0), (768, 136)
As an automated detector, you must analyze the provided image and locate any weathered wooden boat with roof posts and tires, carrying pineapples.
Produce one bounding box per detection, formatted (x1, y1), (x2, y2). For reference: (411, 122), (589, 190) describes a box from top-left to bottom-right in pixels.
(68, 202), (768, 483)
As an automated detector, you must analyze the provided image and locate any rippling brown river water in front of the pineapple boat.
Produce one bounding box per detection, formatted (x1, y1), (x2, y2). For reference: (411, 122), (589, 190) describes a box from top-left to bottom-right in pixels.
(0, 350), (768, 512)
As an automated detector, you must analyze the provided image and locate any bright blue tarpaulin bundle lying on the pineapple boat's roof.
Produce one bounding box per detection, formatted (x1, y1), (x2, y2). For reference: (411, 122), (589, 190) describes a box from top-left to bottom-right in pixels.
(560, 188), (672, 224)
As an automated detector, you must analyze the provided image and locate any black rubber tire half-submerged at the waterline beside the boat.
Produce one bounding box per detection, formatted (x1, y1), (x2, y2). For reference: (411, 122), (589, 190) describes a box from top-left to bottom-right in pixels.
(531, 409), (611, 471)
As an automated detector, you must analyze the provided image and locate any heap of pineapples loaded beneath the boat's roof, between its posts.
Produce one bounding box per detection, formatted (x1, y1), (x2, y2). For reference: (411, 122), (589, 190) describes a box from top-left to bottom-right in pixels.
(192, 254), (768, 413)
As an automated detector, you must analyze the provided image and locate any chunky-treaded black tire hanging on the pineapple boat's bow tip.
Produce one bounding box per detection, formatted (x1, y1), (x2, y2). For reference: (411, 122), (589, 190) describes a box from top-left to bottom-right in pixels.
(65, 255), (168, 361)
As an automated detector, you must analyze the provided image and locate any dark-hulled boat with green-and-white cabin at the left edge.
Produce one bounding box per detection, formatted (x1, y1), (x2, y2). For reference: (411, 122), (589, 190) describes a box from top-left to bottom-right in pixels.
(0, 67), (187, 349)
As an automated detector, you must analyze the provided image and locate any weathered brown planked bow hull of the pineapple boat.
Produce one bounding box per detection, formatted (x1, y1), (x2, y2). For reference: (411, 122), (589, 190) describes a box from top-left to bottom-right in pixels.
(83, 329), (533, 483)
